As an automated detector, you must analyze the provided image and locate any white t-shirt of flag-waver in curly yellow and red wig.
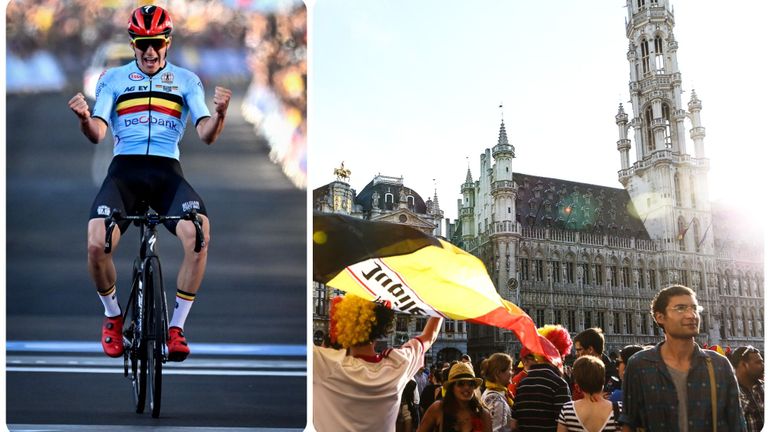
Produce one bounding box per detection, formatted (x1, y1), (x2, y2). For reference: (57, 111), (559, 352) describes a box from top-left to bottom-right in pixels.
(313, 338), (425, 432)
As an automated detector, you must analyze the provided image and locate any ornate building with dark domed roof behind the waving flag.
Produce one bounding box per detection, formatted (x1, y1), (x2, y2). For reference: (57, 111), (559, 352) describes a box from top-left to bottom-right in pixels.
(313, 166), (467, 363)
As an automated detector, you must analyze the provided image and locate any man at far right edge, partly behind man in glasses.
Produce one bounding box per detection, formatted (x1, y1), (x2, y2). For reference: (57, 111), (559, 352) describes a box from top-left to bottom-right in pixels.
(730, 345), (765, 432)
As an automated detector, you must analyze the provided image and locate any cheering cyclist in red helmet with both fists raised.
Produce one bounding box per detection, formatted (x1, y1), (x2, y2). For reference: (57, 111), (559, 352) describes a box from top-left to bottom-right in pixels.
(69, 5), (232, 361)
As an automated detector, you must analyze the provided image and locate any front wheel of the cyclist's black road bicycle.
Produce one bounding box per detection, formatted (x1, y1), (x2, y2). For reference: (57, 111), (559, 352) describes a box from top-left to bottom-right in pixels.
(144, 257), (168, 418)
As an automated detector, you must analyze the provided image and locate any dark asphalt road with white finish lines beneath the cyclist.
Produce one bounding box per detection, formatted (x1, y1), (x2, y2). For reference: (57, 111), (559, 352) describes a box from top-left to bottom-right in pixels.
(5, 85), (307, 430)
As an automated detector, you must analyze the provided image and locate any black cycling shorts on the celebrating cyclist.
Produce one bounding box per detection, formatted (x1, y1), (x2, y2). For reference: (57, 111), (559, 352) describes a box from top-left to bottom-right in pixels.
(90, 155), (206, 234)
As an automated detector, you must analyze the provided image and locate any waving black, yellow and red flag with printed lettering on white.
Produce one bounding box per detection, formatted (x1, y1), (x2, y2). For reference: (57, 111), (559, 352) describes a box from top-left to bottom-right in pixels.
(313, 212), (561, 364)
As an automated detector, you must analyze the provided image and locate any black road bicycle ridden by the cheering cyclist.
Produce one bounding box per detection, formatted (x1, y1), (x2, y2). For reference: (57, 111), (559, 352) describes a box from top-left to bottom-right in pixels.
(104, 209), (204, 418)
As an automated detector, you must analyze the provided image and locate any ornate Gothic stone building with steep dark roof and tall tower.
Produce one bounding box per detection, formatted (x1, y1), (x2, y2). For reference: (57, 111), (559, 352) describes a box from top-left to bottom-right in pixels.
(449, 0), (764, 359)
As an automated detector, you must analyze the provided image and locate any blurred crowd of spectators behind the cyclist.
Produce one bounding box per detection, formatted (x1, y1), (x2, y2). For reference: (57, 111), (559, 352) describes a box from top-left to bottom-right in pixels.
(6, 0), (307, 188)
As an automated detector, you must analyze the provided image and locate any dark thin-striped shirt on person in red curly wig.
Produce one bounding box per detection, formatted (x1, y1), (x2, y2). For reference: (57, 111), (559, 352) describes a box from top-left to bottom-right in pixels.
(511, 363), (570, 432)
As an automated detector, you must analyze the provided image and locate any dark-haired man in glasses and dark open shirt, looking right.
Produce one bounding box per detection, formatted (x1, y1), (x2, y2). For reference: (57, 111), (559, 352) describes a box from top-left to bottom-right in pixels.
(620, 285), (746, 432)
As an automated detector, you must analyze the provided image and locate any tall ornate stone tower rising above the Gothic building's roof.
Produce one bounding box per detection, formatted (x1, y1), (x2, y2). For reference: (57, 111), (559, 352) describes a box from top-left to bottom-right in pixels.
(615, 0), (713, 253)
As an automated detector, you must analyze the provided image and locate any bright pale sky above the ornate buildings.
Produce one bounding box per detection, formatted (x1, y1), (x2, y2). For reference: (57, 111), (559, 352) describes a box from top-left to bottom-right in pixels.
(308, 0), (770, 223)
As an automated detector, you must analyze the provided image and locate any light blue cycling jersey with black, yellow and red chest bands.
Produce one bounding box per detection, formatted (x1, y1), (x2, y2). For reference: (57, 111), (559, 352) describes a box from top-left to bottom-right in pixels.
(93, 61), (211, 160)
